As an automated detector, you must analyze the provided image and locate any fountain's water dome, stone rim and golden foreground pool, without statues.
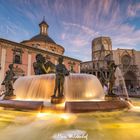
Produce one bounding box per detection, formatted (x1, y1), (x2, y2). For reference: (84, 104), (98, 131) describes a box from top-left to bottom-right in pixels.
(0, 57), (137, 140)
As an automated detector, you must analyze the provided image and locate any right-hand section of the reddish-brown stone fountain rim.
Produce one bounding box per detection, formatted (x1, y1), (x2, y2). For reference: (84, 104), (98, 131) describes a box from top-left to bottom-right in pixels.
(65, 100), (130, 113)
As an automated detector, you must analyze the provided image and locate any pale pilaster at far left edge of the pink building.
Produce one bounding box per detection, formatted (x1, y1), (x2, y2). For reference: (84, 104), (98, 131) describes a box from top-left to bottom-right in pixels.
(0, 48), (6, 86)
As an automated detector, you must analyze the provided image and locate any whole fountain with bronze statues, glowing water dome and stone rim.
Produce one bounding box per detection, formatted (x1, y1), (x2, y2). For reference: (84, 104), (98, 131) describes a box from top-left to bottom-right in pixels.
(0, 54), (129, 112)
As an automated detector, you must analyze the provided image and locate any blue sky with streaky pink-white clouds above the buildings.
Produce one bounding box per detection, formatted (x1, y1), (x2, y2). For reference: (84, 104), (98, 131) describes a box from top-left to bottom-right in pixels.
(0, 0), (140, 61)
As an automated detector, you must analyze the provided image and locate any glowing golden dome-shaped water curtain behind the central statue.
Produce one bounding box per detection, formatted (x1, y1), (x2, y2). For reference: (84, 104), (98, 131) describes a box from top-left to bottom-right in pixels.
(14, 74), (104, 100)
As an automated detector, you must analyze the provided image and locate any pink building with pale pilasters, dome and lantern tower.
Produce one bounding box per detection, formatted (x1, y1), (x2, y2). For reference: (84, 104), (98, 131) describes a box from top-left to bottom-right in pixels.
(0, 20), (81, 85)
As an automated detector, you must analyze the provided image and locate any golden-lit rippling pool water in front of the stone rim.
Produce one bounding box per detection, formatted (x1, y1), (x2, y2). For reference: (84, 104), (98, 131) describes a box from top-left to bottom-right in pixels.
(0, 99), (140, 140)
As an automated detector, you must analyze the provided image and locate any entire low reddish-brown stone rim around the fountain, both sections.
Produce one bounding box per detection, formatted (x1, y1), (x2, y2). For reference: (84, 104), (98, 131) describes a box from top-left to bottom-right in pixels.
(0, 100), (130, 113)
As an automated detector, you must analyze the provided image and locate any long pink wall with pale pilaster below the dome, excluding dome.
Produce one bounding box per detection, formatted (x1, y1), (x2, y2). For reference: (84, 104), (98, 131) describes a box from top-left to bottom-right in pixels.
(0, 39), (80, 85)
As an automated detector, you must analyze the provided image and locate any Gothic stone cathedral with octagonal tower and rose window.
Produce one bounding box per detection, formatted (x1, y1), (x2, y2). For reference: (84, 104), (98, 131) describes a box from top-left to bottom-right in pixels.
(81, 37), (140, 89)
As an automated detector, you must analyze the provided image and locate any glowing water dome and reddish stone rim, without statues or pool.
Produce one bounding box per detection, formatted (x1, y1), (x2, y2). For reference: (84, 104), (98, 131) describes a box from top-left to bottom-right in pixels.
(0, 71), (129, 112)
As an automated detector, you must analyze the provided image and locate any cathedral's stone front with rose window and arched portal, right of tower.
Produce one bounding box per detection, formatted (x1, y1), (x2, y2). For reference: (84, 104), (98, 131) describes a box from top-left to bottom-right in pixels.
(113, 49), (140, 87)
